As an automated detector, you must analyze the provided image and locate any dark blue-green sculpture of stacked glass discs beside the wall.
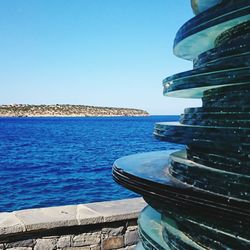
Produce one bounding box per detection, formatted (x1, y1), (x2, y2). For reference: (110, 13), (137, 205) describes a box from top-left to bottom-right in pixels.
(113, 0), (250, 250)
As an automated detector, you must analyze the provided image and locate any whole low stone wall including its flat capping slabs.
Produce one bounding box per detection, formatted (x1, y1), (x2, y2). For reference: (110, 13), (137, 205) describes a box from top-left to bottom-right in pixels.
(0, 198), (146, 250)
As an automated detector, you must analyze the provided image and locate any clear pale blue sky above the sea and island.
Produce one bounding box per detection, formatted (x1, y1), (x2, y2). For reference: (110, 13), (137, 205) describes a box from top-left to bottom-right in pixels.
(0, 0), (200, 115)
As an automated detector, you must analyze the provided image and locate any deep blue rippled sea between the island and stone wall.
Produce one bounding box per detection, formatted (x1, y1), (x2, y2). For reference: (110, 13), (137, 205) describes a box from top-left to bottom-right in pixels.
(0, 116), (182, 212)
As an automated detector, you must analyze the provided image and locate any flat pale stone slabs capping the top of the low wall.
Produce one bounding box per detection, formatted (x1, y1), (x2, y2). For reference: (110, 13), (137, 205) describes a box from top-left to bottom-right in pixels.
(0, 198), (146, 235)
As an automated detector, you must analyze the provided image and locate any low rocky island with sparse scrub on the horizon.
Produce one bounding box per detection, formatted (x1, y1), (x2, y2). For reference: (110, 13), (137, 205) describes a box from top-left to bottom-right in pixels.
(0, 104), (148, 117)
